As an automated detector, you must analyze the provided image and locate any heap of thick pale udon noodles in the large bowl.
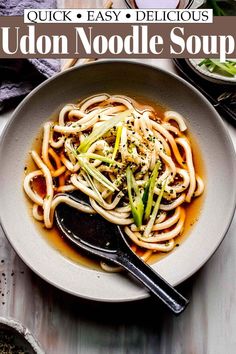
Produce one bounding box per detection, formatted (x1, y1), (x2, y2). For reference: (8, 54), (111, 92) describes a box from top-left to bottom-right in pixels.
(24, 94), (204, 270)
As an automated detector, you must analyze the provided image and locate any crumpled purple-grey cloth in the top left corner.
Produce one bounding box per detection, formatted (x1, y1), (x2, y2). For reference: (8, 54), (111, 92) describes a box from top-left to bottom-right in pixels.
(0, 0), (60, 110)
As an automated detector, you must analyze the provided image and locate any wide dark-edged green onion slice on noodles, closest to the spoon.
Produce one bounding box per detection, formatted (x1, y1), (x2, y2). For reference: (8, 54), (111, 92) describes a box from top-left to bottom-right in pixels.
(126, 167), (144, 227)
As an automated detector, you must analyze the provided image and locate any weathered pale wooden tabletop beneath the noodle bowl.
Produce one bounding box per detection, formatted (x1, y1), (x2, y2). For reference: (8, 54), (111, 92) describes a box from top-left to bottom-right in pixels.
(0, 0), (236, 354)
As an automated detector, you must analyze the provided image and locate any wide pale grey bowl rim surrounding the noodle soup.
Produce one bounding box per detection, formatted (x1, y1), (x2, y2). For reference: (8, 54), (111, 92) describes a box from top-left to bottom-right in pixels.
(0, 60), (236, 302)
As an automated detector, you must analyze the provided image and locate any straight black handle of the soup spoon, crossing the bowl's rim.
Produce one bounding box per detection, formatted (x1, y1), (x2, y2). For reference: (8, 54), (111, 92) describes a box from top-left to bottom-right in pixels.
(116, 238), (189, 315)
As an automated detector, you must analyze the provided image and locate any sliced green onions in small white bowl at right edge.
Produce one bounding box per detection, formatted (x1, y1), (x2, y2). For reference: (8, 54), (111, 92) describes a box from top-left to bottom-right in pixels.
(198, 59), (236, 76)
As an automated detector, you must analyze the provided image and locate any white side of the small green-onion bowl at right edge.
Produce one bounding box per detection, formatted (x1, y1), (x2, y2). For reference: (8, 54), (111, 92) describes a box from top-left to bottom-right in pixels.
(186, 59), (236, 85)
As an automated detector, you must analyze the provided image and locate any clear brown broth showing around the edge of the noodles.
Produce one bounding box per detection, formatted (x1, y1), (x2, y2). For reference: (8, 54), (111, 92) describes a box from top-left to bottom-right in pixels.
(25, 95), (206, 270)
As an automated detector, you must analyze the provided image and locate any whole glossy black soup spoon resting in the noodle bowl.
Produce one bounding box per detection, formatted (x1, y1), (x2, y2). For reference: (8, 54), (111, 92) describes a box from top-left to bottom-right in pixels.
(55, 191), (188, 314)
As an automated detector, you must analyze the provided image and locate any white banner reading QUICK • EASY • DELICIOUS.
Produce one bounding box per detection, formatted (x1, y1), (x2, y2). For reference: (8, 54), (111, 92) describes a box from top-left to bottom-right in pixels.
(24, 9), (213, 24)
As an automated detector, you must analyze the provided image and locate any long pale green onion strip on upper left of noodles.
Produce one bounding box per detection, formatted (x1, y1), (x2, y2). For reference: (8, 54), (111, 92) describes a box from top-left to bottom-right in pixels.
(78, 110), (130, 152)
